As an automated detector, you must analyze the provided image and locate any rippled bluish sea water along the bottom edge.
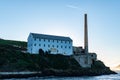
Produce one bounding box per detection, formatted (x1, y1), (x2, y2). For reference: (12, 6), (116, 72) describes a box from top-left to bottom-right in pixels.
(5, 72), (120, 80)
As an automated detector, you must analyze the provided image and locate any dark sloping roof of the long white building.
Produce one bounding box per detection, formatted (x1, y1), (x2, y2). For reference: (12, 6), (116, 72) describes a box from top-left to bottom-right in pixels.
(30, 33), (72, 41)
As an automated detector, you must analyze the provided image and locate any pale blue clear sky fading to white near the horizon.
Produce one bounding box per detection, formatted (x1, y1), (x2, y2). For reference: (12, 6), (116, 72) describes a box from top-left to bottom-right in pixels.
(0, 0), (120, 67)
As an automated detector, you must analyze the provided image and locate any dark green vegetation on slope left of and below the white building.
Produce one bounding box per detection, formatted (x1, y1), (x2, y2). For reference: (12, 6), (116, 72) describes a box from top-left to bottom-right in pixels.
(0, 40), (79, 71)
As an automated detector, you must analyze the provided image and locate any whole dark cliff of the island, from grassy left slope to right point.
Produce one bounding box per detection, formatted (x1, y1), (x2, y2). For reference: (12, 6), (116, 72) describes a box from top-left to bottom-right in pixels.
(0, 40), (114, 76)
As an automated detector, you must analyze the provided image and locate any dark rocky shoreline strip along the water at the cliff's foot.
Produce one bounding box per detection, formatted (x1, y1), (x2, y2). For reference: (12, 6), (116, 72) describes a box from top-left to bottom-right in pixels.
(0, 69), (117, 79)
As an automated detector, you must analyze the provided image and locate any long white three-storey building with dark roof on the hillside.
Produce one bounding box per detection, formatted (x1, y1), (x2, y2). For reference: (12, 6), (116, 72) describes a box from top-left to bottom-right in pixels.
(27, 33), (73, 55)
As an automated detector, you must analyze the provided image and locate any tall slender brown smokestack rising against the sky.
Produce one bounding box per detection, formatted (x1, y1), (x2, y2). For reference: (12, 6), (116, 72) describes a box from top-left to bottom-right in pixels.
(84, 14), (88, 54)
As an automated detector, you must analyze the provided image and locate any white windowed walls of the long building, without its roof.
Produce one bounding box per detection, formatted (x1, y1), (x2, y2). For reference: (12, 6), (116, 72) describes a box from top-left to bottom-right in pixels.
(28, 35), (73, 55)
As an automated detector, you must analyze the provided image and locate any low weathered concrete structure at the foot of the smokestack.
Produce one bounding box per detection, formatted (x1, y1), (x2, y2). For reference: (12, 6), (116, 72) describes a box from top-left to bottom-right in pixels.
(73, 47), (97, 68)
